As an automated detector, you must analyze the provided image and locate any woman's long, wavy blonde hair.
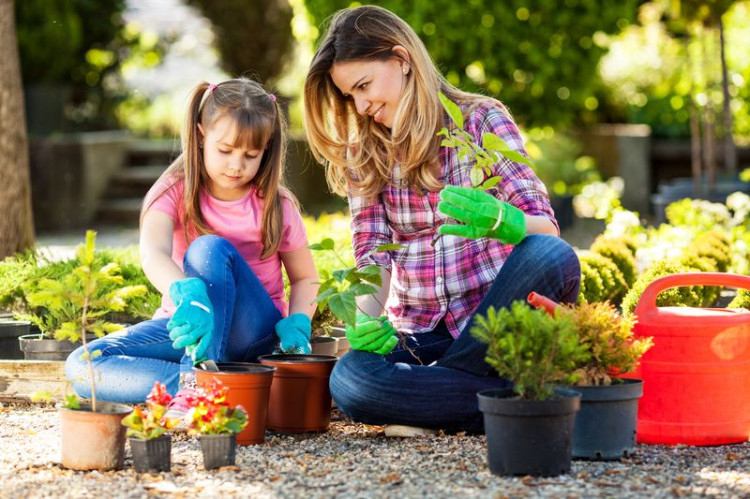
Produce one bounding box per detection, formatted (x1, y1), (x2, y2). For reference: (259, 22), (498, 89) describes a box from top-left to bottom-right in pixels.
(304, 5), (502, 196)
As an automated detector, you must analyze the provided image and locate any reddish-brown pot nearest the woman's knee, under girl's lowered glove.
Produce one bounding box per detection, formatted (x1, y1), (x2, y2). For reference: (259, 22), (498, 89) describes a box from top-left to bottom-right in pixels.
(258, 355), (338, 433)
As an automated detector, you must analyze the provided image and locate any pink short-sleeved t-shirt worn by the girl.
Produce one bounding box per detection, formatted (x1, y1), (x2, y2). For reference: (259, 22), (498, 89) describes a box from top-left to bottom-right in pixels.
(149, 180), (308, 319)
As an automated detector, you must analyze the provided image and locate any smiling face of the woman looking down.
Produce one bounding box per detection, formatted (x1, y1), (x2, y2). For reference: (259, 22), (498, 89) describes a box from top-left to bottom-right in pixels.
(331, 57), (411, 128)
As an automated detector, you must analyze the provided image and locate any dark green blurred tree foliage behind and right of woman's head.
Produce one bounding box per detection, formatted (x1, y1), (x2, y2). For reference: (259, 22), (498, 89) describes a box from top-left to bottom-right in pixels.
(305, 0), (640, 126)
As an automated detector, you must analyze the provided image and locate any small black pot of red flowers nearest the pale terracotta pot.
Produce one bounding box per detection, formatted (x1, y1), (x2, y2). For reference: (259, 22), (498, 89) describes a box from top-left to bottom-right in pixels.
(122, 381), (179, 473)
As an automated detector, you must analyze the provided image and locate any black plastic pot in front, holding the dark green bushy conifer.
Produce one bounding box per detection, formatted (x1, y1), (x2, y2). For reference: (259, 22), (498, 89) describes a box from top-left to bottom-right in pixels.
(477, 388), (581, 476)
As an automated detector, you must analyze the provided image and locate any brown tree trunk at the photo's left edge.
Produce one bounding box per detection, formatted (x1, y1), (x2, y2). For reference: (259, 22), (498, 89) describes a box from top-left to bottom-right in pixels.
(0, 0), (34, 259)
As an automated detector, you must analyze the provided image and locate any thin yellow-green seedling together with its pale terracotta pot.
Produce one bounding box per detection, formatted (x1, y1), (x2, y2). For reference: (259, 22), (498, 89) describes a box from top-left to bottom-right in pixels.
(52, 230), (132, 470)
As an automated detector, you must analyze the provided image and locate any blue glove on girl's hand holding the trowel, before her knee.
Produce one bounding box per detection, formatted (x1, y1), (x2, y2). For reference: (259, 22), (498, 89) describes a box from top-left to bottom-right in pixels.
(167, 277), (214, 362)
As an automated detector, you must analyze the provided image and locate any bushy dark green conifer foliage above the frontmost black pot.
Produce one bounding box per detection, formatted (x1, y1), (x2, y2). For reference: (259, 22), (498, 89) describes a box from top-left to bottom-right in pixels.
(471, 301), (589, 400)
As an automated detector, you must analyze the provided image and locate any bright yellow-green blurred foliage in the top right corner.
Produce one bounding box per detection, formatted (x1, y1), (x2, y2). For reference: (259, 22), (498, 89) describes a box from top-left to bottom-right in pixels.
(600, 1), (750, 141)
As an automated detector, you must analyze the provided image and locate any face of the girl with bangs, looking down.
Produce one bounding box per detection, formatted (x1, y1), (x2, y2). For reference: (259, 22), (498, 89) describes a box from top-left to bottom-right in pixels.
(198, 116), (264, 201)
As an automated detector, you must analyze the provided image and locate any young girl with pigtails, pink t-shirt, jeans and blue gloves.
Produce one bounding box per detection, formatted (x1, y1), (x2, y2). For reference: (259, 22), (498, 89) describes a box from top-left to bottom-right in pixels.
(65, 78), (317, 411)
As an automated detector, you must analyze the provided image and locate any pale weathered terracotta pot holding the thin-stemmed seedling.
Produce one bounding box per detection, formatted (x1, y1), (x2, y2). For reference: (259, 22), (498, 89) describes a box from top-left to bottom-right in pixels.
(60, 402), (133, 470)
